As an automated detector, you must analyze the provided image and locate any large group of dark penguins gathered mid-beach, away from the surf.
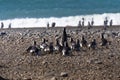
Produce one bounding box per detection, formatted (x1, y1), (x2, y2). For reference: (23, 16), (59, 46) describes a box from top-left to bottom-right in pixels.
(26, 28), (108, 56)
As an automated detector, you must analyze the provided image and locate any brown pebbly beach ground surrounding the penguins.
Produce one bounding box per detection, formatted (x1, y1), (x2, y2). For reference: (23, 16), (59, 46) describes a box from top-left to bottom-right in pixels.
(0, 26), (120, 80)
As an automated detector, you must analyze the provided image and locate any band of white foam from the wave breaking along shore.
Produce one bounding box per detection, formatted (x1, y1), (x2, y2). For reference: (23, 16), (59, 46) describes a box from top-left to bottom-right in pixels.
(0, 13), (120, 28)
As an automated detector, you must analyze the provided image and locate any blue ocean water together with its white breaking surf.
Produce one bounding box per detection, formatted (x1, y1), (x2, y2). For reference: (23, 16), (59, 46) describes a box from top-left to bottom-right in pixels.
(0, 0), (120, 28)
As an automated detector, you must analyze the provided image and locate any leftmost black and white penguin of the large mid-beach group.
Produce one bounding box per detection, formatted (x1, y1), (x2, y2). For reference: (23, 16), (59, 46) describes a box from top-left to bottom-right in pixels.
(27, 41), (40, 55)
